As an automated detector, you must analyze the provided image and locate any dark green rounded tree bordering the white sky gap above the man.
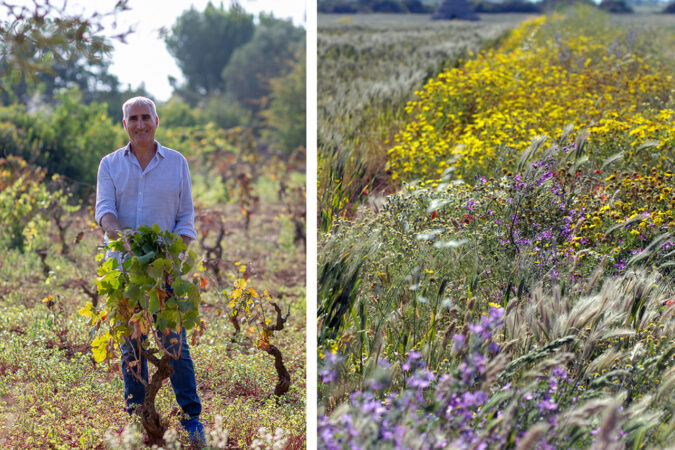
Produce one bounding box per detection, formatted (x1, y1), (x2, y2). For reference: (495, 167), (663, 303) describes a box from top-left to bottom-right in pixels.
(165, 2), (254, 97)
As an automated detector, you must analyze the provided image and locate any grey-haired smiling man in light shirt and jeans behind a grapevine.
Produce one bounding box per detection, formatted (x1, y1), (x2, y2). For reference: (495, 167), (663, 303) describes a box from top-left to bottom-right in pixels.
(96, 97), (204, 441)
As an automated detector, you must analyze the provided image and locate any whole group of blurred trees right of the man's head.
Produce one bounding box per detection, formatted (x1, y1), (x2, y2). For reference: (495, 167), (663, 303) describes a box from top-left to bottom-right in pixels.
(163, 3), (305, 152)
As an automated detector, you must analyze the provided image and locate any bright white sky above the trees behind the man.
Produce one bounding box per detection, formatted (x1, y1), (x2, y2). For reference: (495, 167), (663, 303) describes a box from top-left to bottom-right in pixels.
(3, 0), (307, 102)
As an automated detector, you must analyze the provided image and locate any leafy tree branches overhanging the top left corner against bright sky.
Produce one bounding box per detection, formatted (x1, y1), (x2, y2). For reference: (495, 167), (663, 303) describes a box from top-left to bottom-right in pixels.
(0, 0), (131, 92)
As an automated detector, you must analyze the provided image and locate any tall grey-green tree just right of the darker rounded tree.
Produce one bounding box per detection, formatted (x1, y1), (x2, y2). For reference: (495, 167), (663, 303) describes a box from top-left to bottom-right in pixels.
(222, 14), (305, 117)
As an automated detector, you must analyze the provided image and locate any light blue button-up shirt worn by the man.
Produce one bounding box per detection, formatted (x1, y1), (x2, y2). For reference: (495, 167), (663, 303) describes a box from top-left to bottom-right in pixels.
(95, 143), (197, 239)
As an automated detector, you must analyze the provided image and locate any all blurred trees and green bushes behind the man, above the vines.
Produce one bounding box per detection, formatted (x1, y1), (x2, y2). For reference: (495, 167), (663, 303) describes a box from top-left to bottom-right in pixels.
(0, 1), (305, 210)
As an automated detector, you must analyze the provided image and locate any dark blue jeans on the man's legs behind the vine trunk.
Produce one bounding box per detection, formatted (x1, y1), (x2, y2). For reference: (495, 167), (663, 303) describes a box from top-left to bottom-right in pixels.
(121, 328), (202, 419)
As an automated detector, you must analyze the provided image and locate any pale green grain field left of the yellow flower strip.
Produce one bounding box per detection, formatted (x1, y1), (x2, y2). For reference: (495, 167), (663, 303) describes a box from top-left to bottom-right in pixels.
(317, 14), (526, 230)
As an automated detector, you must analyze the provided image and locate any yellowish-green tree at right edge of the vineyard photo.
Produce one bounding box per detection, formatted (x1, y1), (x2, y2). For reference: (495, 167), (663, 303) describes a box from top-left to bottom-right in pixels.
(262, 48), (307, 154)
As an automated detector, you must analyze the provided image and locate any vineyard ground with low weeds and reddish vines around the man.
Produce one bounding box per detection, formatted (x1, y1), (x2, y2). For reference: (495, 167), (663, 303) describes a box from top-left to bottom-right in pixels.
(0, 125), (306, 449)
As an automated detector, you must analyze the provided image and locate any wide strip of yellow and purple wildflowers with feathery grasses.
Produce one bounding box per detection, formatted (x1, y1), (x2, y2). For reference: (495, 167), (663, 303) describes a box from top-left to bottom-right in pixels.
(318, 7), (675, 449)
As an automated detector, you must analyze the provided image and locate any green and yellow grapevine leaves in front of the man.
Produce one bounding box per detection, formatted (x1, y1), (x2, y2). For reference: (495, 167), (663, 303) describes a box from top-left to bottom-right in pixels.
(80, 225), (201, 361)
